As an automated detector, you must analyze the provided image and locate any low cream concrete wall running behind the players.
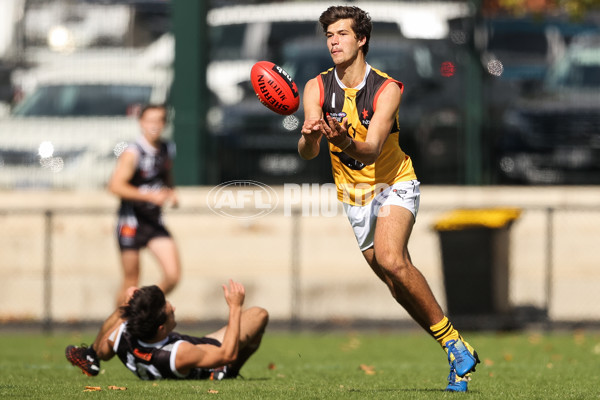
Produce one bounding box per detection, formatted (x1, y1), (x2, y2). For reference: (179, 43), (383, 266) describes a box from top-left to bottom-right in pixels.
(0, 186), (600, 321)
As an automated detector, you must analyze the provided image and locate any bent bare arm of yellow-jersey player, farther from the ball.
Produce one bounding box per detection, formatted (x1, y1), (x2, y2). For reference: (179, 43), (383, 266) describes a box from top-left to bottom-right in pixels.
(321, 84), (402, 165)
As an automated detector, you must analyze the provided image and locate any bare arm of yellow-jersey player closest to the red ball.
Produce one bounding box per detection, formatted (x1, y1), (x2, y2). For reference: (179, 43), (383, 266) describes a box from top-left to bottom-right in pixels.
(298, 78), (323, 160)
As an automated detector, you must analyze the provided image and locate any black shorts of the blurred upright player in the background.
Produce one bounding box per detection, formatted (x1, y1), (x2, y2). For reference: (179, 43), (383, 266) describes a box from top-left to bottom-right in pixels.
(117, 209), (171, 251)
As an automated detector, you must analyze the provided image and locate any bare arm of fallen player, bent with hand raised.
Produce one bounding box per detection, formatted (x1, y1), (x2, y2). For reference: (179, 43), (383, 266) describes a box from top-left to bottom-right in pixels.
(175, 280), (245, 374)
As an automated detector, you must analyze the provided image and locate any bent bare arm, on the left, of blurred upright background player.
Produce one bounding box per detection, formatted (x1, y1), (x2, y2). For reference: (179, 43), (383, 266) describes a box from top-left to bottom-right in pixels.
(108, 151), (172, 206)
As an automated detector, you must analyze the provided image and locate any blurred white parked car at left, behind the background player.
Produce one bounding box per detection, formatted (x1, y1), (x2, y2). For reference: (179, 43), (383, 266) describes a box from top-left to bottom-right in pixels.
(0, 64), (171, 189)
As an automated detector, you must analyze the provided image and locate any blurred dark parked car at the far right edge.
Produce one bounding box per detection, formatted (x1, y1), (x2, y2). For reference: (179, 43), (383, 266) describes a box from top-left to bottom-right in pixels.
(497, 34), (600, 184)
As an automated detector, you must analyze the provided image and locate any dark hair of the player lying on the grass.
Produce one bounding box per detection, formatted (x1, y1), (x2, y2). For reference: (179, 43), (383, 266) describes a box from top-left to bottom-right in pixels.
(121, 285), (167, 341)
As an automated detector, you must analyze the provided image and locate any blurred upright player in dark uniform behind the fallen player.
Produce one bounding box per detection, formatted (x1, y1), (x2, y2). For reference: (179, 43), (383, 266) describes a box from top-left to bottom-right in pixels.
(108, 104), (181, 304)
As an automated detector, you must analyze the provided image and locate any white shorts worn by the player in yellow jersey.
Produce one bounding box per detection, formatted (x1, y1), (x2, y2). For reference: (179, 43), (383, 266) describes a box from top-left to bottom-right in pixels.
(343, 180), (421, 251)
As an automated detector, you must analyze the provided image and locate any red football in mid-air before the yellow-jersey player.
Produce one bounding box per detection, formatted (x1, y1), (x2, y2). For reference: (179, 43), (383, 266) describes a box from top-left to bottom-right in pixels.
(250, 61), (300, 115)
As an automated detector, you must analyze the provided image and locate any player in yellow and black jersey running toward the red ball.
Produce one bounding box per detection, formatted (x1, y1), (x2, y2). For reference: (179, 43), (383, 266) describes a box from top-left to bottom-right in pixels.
(298, 6), (479, 392)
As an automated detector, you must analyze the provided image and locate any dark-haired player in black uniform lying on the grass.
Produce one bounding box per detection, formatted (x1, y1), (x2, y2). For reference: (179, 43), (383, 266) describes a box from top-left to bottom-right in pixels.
(65, 280), (269, 380)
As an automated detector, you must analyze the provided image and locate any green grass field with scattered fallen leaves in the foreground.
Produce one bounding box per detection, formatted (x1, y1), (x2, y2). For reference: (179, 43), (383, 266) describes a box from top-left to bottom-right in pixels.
(0, 332), (600, 400)
